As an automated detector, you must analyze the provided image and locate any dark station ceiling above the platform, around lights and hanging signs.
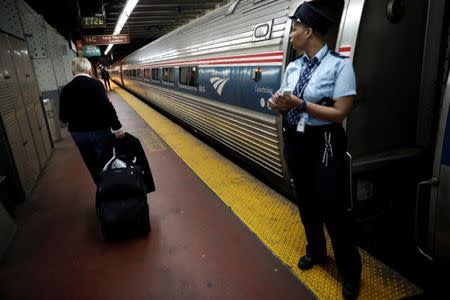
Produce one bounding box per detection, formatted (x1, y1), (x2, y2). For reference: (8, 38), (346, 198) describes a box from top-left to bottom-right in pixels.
(25, 0), (230, 59)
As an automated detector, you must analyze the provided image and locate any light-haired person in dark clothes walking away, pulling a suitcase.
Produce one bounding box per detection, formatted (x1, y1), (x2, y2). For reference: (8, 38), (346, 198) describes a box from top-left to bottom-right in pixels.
(59, 57), (125, 184)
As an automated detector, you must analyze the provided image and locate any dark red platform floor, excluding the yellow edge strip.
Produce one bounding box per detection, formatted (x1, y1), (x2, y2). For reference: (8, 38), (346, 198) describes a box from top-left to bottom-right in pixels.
(0, 92), (314, 299)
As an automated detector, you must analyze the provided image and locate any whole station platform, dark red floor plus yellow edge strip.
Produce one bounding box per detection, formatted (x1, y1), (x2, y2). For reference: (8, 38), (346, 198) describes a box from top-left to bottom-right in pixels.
(0, 86), (422, 299)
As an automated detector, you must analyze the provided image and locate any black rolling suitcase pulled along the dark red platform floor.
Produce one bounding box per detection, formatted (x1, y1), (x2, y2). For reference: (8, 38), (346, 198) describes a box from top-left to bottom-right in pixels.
(96, 152), (150, 239)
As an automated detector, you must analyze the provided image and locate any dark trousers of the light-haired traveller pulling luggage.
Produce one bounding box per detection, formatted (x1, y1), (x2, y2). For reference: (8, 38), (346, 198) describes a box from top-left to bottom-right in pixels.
(71, 129), (112, 184)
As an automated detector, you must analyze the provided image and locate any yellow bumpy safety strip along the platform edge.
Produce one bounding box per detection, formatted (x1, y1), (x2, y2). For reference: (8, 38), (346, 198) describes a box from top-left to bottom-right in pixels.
(115, 87), (422, 299)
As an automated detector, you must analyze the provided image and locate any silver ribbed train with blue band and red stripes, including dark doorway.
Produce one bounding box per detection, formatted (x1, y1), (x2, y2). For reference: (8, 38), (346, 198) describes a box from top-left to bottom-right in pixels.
(110, 0), (450, 288)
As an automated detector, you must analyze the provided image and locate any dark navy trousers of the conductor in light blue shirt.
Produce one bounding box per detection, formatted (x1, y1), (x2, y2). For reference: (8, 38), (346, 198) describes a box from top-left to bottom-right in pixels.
(284, 124), (361, 282)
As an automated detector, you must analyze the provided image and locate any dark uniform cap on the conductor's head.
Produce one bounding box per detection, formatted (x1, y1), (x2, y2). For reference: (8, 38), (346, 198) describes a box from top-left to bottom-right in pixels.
(289, 2), (333, 35)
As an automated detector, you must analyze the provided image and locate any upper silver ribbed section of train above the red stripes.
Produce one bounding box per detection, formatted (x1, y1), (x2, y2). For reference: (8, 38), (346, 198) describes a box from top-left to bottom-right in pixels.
(119, 0), (303, 66)
